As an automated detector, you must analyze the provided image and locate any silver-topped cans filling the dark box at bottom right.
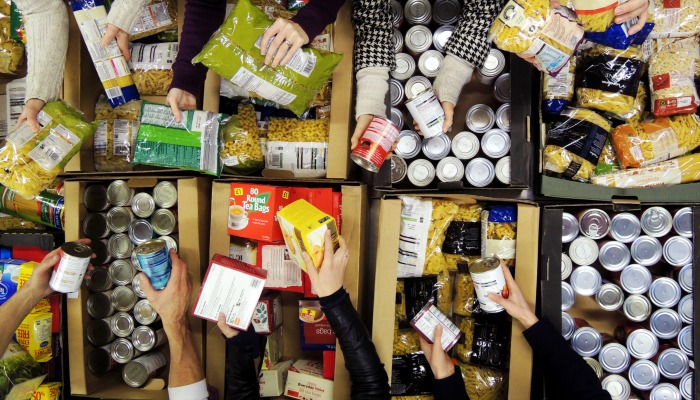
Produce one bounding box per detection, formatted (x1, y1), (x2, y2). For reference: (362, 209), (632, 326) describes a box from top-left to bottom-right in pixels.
(561, 206), (693, 399)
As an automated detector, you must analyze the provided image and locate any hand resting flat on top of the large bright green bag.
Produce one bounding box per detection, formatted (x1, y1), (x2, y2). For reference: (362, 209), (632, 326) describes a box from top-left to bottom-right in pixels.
(260, 18), (309, 68)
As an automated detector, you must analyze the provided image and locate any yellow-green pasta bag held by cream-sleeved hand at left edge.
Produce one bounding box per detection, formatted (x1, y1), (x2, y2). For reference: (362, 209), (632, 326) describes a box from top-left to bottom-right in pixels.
(0, 100), (97, 198)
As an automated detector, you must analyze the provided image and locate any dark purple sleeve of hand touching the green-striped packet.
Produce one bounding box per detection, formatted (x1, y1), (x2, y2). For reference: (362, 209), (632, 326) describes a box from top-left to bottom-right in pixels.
(170, 0), (226, 96)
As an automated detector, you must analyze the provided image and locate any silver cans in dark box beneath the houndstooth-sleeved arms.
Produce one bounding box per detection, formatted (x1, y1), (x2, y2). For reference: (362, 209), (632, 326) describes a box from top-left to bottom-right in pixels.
(390, 0), (511, 188)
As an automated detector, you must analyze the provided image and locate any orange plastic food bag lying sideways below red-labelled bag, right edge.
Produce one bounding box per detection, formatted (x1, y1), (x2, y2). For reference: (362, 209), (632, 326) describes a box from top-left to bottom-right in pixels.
(611, 114), (700, 168)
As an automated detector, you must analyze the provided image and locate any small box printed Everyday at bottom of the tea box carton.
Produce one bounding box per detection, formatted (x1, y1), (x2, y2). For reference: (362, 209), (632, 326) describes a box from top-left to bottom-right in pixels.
(284, 360), (333, 400)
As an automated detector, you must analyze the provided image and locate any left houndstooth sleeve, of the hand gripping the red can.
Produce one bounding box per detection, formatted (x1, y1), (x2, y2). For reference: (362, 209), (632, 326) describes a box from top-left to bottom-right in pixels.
(352, 0), (396, 71)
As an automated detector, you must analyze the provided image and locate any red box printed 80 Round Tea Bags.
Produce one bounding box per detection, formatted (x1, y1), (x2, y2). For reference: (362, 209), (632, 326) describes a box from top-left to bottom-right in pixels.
(227, 182), (291, 242)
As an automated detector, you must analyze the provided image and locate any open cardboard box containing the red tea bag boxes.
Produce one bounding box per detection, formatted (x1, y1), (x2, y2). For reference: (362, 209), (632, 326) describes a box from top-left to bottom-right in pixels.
(206, 180), (370, 400)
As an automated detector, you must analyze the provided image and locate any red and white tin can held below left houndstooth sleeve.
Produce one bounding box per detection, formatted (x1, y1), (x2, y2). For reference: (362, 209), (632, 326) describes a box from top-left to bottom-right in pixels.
(350, 117), (399, 172)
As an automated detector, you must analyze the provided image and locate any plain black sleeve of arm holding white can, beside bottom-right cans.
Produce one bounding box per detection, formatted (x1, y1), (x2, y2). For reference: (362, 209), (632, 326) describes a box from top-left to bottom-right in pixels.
(523, 318), (611, 400)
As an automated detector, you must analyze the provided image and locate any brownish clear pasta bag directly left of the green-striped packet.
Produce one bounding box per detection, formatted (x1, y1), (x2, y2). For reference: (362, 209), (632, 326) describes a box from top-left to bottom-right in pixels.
(92, 96), (141, 172)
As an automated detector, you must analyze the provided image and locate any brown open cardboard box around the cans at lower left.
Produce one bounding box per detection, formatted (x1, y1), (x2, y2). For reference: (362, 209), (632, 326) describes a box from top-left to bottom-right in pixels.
(65, 176), (211, 399)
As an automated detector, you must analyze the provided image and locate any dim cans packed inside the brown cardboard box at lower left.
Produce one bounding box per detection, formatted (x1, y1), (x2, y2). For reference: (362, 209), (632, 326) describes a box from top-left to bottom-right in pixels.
(82, 180), (178, 387)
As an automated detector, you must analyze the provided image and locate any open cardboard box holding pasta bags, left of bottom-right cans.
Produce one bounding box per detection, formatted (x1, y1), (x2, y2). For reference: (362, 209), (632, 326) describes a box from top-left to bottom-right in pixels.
(372, 195), (540, 400)
